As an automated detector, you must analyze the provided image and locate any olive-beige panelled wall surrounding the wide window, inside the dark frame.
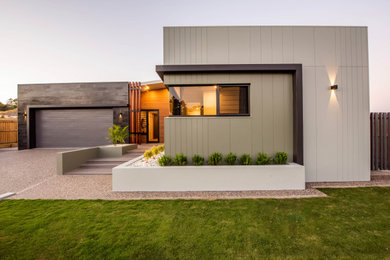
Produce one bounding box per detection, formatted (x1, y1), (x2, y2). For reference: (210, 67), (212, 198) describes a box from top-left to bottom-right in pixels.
(164, 73), (293, 161)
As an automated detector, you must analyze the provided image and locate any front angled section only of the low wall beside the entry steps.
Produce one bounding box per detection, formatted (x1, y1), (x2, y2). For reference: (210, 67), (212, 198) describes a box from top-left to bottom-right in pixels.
(57, 147), (99, 175)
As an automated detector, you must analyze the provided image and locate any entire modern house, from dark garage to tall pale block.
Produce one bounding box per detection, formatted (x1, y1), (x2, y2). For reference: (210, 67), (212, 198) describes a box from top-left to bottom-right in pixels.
(18, 26), (370, 182)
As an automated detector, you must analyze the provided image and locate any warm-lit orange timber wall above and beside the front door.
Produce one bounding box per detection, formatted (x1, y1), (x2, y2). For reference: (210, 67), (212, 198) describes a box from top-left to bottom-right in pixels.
(141, 89), (169, 143)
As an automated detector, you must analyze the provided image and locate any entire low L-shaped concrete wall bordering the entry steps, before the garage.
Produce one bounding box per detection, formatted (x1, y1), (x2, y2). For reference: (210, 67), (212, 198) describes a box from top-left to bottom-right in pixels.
(57, 144), (137, 175)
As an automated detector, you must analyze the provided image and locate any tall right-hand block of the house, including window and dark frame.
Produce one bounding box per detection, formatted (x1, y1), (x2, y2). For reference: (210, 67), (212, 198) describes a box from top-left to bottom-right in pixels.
(157, 26), (370, 181)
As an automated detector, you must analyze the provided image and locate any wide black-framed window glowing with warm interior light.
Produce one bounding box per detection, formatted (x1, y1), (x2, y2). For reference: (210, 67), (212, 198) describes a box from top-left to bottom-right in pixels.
(169, 85), (249, 116)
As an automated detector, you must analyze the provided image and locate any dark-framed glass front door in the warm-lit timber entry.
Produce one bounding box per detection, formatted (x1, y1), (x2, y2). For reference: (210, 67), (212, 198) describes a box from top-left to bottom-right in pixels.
(141, 109), (160, 143)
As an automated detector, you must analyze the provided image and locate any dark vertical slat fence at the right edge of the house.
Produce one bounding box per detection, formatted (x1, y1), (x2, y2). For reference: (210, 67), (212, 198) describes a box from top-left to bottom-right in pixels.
(370, 113), (390, 170)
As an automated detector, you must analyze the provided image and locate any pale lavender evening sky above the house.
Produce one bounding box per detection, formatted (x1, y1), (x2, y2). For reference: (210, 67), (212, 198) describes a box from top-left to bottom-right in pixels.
(0, 0), (390, 112)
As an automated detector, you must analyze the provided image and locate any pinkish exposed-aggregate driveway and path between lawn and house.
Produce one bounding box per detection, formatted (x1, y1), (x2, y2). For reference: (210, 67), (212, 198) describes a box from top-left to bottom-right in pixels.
(0, 146), (390, 200)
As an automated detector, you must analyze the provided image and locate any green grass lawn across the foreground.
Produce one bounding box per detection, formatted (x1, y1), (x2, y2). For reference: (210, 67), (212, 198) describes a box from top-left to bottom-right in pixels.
(0, 188), (390, 259)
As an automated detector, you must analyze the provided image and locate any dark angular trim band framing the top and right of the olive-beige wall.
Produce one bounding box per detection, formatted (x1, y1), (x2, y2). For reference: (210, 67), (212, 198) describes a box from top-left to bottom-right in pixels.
(156, 64), (303, 165)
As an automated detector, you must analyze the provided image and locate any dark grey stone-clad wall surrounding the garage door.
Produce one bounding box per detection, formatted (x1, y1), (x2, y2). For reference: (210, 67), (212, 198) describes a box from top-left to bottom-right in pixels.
(18, 82), (129, 149)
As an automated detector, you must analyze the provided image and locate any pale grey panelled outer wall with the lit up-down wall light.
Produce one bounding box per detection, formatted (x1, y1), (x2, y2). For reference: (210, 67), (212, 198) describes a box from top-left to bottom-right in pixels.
(164, 26), (370, 181)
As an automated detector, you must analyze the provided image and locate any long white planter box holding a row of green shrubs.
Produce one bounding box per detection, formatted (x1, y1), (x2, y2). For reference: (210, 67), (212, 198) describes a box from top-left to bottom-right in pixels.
(112, 163), (305, 191)
